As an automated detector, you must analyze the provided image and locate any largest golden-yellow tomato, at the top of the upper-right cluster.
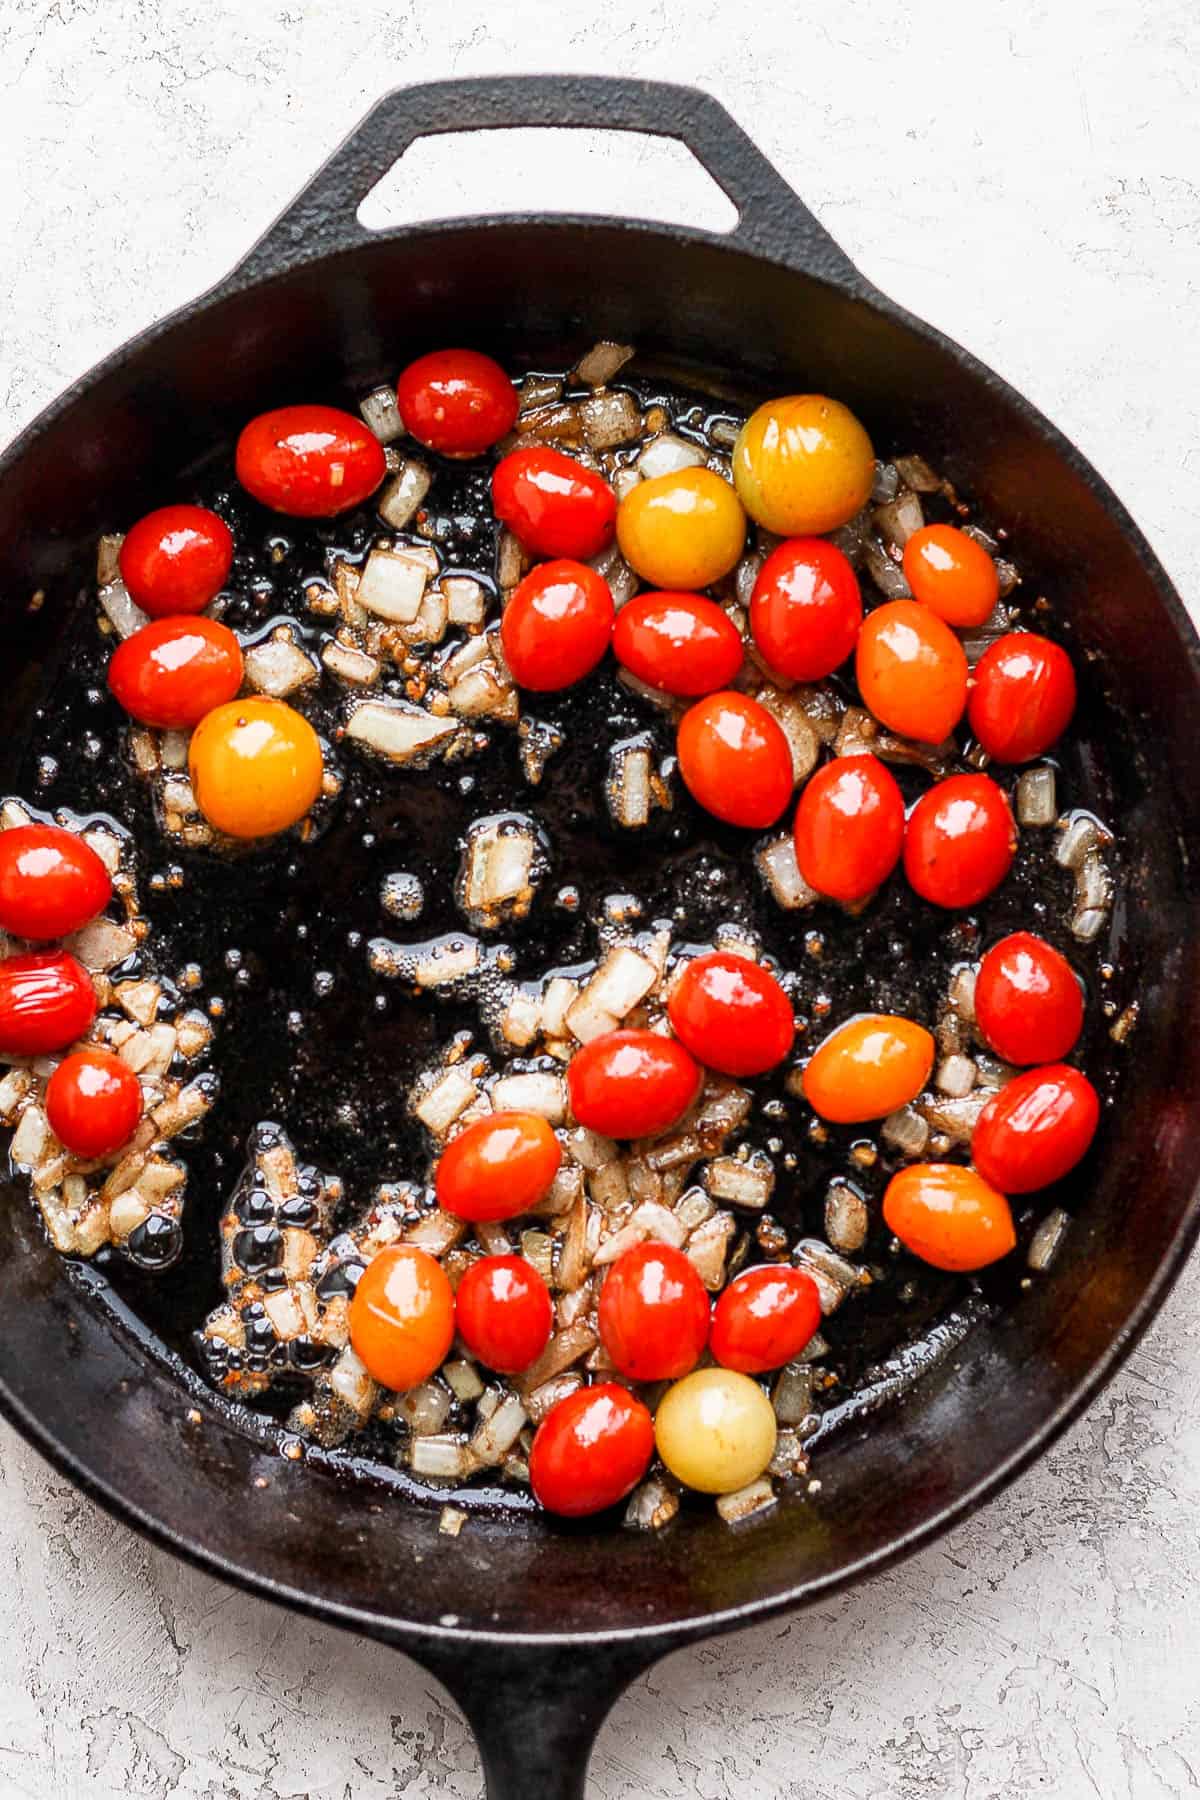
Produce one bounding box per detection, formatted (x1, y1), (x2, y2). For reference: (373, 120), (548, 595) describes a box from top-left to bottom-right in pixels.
(734, 394), (874, 538)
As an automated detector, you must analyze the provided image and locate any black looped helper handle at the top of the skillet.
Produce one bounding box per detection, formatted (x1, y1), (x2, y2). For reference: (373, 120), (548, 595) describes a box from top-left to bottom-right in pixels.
(232, 76), (869, 293)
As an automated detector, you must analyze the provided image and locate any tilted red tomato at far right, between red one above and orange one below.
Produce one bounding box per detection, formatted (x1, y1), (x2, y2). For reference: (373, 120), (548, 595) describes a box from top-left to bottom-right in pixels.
(972, 1062), (1099, 1193)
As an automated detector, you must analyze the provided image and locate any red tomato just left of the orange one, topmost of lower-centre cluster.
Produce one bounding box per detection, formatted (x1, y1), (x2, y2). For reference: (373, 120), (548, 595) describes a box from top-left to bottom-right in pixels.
(667, 950), (795, 1075)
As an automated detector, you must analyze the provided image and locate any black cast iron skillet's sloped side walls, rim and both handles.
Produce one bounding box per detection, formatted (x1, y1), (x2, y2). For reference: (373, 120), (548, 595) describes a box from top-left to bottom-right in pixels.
(0, 77), (1200, 1796)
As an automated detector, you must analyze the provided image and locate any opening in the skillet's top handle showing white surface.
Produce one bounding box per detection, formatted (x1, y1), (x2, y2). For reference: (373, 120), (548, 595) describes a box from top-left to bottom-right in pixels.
(358, 126), (738, 232)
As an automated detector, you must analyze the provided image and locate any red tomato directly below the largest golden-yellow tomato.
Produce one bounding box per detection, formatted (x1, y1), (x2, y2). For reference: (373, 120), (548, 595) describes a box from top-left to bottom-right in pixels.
(750, 538), (862, 680)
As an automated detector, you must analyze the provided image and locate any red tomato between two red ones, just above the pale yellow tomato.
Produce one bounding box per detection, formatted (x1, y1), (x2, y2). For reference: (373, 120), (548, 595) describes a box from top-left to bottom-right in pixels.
(597, 1244), (709, 1381)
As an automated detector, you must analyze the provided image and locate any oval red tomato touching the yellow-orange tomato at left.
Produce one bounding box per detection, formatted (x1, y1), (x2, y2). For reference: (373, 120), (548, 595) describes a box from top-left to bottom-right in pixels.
(108, 619), (243, 731)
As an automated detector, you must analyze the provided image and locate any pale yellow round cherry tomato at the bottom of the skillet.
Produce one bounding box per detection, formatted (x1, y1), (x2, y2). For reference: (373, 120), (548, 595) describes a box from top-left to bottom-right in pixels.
(655, 1368), (775, 1494)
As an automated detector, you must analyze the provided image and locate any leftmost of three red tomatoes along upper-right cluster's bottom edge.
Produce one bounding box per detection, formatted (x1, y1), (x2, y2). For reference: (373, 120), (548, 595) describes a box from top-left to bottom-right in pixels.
(676, 688), (795, 826)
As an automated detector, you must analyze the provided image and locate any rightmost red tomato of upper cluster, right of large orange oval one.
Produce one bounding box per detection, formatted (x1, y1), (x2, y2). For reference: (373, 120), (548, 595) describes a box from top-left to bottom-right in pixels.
(966, 632), (1076, 763)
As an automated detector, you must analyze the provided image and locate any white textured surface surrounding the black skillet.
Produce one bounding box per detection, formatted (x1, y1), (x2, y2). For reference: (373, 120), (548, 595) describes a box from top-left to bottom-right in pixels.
(0, 0), (1200, 1800)
